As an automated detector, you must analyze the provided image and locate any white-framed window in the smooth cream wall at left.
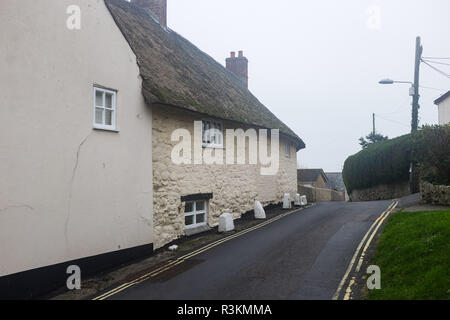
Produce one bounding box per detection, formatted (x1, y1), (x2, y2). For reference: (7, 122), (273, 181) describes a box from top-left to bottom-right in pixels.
(94, 87), (117, 130)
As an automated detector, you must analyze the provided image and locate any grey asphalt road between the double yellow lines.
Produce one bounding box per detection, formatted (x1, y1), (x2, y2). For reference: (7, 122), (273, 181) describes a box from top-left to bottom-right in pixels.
(105, 201), (391, 300)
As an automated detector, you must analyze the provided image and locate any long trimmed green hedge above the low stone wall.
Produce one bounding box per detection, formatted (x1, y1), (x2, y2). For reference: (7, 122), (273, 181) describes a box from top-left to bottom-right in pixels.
(342, 126), (450, 193)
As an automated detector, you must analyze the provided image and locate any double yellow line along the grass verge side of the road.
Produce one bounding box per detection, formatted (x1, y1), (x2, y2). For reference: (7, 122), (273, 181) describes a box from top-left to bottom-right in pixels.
(333, 201), (398, 300)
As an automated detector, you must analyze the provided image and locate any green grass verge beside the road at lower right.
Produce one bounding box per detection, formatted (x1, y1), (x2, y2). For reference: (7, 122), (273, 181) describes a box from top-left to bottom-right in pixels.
(367, 211), (450, 300)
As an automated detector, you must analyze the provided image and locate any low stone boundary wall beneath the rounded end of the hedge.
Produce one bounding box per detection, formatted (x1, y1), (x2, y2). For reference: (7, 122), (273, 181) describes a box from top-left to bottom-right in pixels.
(349, 181), (410, 202)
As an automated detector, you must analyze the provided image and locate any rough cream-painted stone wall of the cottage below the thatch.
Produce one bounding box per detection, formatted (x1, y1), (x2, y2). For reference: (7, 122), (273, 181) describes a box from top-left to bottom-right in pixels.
(152, 106), (297, 248)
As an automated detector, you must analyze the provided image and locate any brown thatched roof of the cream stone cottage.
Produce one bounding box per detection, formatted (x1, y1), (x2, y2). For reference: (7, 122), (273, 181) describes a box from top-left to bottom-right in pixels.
(105, 0), (305, 149)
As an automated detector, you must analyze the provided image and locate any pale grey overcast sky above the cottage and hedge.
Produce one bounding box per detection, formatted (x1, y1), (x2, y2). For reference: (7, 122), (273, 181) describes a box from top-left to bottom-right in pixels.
(168, 0), (450, 171)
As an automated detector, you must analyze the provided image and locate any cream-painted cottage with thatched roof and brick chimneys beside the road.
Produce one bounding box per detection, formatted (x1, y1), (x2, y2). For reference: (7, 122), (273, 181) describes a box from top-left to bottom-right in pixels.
(0, 0), (305, 298)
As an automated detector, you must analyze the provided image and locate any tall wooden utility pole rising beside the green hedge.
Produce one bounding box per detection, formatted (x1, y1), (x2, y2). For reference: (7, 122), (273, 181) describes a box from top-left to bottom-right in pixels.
(409, 37), (423, 194)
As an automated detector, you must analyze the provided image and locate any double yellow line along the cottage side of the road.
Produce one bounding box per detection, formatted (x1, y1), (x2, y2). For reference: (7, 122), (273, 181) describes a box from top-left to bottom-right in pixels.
(93, 208), (303, 300)
